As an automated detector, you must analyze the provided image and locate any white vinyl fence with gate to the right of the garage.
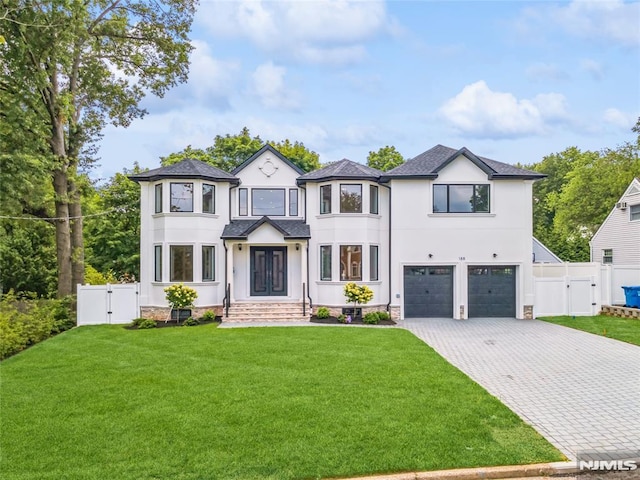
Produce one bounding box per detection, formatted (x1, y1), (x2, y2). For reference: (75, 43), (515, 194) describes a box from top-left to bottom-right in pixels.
(533, 263), (640, 317)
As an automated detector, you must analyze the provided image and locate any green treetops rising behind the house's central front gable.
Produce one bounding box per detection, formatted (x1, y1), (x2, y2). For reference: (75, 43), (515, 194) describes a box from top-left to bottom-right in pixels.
(160, 127), (320, 172)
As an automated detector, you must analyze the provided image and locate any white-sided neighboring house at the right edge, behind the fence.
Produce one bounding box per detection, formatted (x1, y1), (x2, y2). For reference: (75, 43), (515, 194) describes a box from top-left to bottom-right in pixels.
(590, 178), (640, 266)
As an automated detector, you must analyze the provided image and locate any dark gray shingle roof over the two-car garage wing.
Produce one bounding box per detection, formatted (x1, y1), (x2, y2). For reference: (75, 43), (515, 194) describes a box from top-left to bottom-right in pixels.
(381, 145), (546, 181)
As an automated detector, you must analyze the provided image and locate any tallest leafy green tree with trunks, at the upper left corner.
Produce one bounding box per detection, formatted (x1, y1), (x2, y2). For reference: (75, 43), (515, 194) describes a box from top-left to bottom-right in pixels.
(0, 0), (196, 296)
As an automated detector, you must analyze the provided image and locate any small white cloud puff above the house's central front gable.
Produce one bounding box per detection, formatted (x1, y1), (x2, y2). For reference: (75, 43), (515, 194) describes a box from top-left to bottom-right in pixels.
(250, 62), (300, 110)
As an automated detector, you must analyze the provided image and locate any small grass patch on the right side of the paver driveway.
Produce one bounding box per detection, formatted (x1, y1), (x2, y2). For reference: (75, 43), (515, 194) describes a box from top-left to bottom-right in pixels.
(539, 315), (640, 345)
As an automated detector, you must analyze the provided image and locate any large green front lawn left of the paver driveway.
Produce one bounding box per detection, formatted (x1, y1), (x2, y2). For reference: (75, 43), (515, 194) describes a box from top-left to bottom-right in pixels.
(0, 325), (563, 480)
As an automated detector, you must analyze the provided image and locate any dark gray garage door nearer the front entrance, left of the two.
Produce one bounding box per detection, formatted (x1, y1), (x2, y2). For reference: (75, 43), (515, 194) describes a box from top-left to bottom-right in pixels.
(404, 266), (453, 318)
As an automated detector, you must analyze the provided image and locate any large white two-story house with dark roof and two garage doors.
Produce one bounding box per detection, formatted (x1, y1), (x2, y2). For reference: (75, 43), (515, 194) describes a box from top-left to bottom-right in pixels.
(130, 145), (544, 320)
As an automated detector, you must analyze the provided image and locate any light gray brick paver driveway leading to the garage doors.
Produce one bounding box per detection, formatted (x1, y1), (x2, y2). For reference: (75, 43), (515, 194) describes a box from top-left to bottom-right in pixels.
(400, 318), (640, 460)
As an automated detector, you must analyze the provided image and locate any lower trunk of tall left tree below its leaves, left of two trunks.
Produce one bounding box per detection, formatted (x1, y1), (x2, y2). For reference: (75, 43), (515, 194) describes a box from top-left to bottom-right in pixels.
(53, 169), (73, 298)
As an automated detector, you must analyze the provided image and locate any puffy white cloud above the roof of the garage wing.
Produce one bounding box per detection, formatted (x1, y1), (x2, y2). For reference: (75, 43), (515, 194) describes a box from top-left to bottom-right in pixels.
(439, 81), (568, 138)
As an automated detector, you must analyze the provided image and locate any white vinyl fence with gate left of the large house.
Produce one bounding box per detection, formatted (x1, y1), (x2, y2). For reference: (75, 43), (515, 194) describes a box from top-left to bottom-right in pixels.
(78, 283), (140, 326)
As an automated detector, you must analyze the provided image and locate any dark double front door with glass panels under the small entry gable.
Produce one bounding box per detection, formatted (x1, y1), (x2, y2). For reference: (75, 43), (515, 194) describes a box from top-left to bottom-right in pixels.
(250, 247), (287, 297)
